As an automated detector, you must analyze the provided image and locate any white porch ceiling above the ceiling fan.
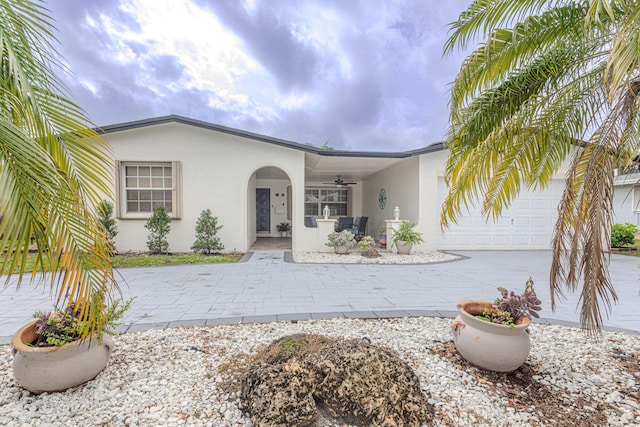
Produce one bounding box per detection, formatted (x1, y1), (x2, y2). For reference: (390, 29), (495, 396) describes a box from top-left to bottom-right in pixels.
(304, 153), (402, 182)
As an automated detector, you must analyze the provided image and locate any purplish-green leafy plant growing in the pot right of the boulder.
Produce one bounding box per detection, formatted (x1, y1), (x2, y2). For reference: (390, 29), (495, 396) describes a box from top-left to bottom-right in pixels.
(476, 277), (542, 328)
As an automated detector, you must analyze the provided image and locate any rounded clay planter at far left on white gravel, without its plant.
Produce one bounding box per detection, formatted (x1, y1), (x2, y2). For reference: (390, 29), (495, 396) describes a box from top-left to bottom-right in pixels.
(11, 320), (114, 394)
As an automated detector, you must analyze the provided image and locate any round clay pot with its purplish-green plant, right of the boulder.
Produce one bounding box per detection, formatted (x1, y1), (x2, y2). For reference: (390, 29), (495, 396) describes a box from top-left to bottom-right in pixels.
(451, 278), (542, 372)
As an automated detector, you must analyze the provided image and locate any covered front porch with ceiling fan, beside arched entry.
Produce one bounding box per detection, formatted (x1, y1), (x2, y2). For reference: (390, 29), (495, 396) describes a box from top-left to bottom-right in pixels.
(249, 145), (444, 252)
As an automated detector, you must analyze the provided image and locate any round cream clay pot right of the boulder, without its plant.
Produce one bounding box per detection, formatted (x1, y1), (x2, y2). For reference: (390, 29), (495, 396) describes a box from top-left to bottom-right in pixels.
(451, 301), (531, 372)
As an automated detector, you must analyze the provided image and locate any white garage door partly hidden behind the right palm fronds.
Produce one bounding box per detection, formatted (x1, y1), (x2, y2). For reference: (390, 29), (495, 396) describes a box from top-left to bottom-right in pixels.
(438, 178), (564, 250)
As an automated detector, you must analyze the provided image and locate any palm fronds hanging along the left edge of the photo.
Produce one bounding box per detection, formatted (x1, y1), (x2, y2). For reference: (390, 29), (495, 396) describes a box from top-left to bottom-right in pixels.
(0, 0), (117, 336)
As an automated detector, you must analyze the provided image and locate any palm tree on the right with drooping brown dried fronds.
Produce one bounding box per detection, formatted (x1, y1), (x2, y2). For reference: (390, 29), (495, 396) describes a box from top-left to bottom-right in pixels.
(441, 0), (640, 333)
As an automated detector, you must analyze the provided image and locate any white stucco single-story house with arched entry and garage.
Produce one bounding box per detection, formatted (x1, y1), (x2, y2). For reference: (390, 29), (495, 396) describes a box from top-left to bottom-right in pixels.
(101, 115), (640, 252)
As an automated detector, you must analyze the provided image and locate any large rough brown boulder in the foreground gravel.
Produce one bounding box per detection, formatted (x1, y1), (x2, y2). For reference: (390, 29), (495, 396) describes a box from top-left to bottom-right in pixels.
(241, 334), (433, 427)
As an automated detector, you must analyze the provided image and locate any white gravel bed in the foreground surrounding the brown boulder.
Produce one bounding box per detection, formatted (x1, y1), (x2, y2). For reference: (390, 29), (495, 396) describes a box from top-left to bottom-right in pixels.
(0, 317), (640, 426)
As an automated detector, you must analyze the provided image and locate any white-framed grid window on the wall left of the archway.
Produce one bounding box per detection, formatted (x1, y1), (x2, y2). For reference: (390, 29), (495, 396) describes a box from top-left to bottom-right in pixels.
(118, 162), (181, 218)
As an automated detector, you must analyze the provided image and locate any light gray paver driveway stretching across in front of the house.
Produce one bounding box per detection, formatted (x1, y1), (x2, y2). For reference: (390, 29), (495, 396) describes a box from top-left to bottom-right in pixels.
(0, 251), (640, 343)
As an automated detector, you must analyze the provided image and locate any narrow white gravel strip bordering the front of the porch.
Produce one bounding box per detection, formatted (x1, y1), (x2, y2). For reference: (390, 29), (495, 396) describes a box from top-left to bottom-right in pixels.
(293, 248), (460, 264)
